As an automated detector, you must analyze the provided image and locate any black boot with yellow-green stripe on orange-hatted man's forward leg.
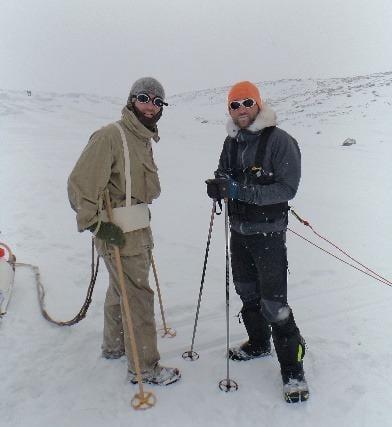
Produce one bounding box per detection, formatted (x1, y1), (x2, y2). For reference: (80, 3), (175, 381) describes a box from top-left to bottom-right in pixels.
(272, 313), (309, 403)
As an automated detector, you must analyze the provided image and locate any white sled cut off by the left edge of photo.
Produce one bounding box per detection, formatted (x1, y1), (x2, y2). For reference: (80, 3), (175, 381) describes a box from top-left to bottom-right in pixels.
(0, 242), (15, 317)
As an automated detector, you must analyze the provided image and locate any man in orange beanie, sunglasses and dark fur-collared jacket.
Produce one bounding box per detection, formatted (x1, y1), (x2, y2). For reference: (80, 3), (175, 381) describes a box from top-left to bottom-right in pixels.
(206, 81), (309, 402)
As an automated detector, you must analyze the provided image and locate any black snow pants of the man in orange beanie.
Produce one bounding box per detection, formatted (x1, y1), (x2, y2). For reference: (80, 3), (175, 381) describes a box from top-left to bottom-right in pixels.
(230, 231), (305, 371)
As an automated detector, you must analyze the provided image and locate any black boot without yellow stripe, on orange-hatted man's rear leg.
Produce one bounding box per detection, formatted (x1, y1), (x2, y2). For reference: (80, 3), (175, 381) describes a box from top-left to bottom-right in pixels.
(229, 304), (271, 361)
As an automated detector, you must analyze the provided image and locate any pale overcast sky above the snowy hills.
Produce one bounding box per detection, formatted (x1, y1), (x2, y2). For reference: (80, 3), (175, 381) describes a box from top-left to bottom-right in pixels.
(0, 0), (392, 97)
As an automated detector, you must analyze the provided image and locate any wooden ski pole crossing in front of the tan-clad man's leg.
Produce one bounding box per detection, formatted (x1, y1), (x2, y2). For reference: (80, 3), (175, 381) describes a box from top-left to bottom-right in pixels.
(105, 190), (156, 409)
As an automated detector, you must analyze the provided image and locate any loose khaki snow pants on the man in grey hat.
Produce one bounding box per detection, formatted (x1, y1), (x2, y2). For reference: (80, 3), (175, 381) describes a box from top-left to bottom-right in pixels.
(102, 251), (160, 372)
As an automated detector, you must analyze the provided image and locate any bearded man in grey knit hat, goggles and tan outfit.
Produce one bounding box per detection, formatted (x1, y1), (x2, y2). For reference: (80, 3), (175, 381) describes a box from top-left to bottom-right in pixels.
(68, 77), (181, 385)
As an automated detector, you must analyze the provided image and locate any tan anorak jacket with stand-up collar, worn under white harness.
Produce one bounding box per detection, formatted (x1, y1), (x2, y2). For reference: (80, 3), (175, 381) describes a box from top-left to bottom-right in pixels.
(68, 107), (161, 256)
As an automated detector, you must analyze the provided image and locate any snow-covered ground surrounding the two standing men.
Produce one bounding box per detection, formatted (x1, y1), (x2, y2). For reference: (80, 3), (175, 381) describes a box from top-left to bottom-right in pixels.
(0, 72), (392, 427)
